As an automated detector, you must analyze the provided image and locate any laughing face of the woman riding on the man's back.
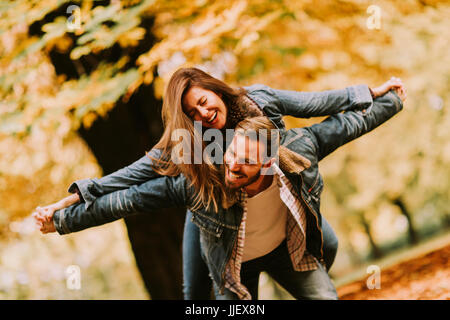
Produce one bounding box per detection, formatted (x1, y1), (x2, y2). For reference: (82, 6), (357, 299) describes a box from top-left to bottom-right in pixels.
(182, 86), (227, 129)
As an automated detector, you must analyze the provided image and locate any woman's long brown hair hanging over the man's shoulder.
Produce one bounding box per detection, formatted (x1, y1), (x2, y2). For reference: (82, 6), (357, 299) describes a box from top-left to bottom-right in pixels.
(147, 68), (246, 211)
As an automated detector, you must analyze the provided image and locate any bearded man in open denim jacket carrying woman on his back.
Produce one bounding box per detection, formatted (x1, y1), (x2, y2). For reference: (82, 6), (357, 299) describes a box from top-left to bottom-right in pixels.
(37, 88), (402, 299)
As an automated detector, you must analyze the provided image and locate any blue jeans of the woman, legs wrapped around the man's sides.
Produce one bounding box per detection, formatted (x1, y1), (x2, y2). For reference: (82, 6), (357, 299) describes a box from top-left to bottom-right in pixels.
(183, 210), (338, 300)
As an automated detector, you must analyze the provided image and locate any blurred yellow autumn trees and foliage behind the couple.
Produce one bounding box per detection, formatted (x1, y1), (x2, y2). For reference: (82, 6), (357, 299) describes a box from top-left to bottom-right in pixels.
(0, 0), (450, 299)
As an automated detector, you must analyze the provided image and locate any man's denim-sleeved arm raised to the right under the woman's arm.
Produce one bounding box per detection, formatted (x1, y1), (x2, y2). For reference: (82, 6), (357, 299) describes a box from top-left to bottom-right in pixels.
(304, 91), (403, 160)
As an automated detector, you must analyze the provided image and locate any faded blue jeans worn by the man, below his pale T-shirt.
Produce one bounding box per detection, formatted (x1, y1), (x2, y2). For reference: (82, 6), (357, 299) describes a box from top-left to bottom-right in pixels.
(214, 240), (338, 300)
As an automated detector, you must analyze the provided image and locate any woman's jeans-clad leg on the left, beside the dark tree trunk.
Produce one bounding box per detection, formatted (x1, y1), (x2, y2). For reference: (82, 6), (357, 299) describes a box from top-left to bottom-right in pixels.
(183, 210), (212, 300)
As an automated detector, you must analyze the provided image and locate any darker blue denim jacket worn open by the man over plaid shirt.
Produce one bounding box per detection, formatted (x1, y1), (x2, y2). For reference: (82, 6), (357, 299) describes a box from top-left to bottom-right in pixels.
(53, 91), (403, 289)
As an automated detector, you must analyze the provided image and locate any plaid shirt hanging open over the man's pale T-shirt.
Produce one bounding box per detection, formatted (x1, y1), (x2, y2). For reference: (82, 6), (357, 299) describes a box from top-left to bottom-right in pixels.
(225, 164), (317, 300)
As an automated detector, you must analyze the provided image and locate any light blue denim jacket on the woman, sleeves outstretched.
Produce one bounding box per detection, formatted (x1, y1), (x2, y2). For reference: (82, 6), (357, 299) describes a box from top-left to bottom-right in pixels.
(69, 84), (373, 208)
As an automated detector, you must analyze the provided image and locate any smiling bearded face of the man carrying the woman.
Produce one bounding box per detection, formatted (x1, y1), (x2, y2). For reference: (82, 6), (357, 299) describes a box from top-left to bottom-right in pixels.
(224, 133), (265, 189)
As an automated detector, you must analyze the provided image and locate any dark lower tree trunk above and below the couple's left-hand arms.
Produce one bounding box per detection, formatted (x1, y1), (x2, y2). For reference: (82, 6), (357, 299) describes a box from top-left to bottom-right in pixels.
(79, 86), (185, 299)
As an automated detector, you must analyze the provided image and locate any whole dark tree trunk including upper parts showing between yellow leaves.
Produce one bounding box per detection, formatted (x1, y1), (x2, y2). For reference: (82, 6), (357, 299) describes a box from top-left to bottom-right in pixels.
(36, 6), (185, 299)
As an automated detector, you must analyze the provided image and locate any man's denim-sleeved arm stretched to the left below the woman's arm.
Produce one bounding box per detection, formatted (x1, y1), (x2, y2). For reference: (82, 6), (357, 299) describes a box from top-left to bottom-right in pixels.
(53, 175), (189, 234)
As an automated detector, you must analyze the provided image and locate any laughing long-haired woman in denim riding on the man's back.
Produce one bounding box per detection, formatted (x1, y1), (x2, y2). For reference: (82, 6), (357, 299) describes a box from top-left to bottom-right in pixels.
(33, 68), (402, 299)
